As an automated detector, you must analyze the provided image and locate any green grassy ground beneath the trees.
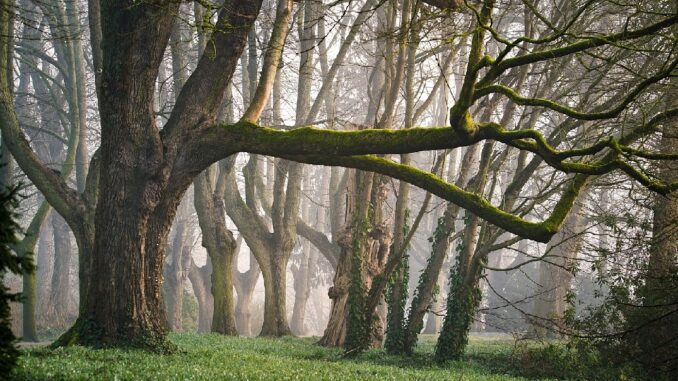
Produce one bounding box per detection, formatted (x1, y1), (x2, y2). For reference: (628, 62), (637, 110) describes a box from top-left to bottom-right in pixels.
(13, 334), (556, 381)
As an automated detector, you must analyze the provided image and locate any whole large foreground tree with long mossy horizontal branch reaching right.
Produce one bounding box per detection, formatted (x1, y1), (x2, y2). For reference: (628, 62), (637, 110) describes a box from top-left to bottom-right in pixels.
(0, 0), (678, 348)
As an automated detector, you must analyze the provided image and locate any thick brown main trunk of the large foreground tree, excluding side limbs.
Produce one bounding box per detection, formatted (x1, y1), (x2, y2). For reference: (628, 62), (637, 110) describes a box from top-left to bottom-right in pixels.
(54, 3), (183, 348)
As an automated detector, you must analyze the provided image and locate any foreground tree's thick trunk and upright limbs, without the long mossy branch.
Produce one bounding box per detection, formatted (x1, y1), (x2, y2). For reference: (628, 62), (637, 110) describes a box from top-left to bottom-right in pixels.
(0, 1), (261, 349)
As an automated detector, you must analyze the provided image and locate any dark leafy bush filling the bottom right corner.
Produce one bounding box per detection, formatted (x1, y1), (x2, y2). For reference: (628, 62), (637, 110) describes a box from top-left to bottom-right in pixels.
(566, 270), (678, 380)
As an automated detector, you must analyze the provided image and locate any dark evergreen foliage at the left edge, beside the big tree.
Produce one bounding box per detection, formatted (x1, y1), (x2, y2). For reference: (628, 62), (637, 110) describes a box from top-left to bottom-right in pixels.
(0, 183), (33, 374)
